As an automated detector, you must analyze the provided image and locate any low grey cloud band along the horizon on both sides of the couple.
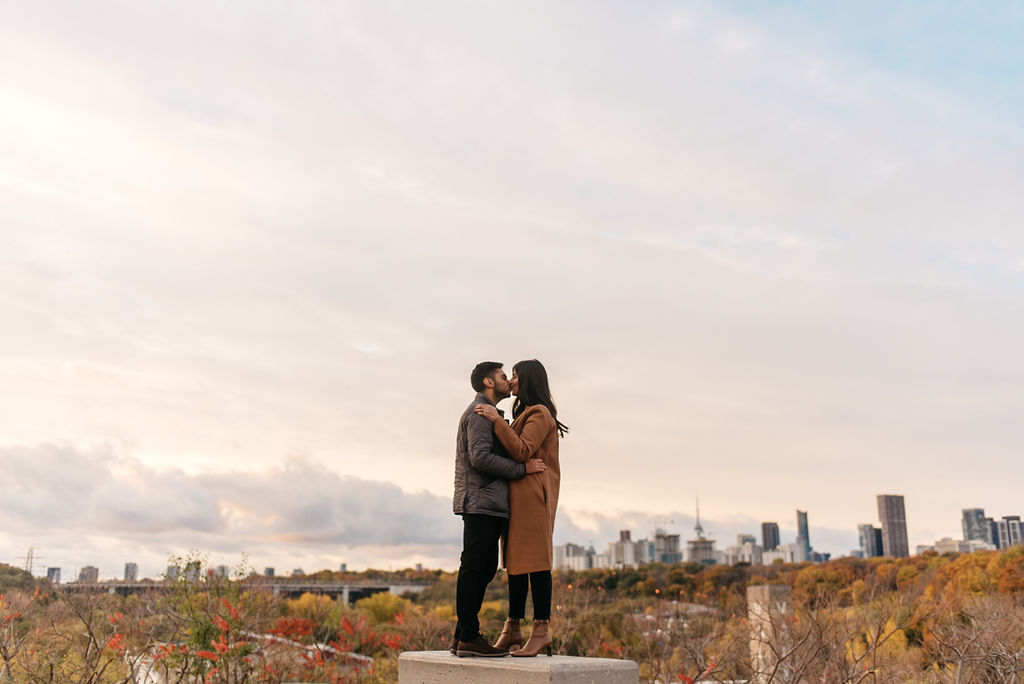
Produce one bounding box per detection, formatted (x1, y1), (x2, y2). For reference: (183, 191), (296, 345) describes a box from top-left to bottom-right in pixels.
(0, 444), (855, 576)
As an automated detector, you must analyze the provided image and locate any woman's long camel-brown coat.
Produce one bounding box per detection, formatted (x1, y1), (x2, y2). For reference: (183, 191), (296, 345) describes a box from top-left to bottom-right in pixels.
(495, 404), (561, 574)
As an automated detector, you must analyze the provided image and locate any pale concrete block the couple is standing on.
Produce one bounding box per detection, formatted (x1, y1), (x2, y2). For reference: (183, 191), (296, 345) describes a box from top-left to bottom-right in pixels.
(398, 651), (640, 684)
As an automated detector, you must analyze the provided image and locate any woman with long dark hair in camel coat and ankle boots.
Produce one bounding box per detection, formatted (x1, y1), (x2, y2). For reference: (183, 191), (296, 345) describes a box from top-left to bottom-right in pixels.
(474, 358), (568, 656)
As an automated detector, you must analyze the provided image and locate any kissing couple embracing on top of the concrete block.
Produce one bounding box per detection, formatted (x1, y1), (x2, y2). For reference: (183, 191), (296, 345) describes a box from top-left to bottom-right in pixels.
(450, 358), (568, 657)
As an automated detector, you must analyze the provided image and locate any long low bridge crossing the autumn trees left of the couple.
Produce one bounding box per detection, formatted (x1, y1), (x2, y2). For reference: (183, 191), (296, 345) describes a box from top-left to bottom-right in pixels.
(57, 578), (432, 605)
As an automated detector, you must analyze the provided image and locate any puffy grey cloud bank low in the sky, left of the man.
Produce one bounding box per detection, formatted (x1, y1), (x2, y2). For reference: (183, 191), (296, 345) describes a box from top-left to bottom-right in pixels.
(0, 444), (459, 550)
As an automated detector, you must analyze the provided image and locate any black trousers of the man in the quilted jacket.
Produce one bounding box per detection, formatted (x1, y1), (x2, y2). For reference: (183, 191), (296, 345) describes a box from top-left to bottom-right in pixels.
(455, 513), (508, 641)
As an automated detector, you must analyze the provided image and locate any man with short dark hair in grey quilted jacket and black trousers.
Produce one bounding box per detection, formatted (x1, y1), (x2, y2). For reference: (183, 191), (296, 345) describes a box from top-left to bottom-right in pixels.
(451, 361), (546, 657)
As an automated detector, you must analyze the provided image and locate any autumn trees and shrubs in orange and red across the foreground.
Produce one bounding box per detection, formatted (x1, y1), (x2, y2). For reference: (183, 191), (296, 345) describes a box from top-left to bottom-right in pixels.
(0, 547), (1024, 684)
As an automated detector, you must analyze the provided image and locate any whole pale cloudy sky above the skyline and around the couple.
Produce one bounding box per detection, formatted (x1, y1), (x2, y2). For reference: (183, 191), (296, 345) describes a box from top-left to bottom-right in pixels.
(0, 0), (1024, 578)
